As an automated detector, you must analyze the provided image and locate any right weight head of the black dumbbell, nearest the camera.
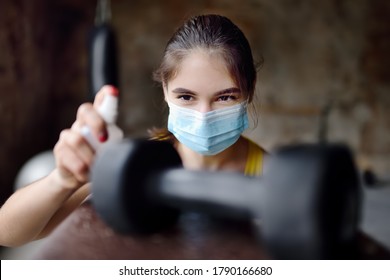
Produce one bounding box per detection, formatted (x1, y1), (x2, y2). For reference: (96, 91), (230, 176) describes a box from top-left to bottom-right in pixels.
(260, 144), (362, 259)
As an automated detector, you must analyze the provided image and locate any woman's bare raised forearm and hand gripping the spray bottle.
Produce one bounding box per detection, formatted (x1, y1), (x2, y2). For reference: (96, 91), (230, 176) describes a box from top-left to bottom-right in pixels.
(0, 86), (115, 247)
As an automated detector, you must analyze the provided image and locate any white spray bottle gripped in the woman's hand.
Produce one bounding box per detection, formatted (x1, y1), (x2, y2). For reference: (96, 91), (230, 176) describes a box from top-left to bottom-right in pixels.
(81, 87), (123, 150)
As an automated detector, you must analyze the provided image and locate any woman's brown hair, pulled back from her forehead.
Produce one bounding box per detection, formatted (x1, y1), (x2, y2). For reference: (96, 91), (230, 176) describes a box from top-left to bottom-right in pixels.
(152, 14), (262, 138)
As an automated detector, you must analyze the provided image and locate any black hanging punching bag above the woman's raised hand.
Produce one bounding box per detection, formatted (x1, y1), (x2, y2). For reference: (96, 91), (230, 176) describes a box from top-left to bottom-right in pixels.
(88, 0), (118, 100)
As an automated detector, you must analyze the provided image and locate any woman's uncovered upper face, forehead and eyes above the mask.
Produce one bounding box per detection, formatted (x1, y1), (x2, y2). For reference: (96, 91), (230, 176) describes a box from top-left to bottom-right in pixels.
(163, 51), (245, 113)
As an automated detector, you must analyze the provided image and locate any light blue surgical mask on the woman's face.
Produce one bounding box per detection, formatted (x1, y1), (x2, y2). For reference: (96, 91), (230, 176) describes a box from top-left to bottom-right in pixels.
(168, 101), (248, 155)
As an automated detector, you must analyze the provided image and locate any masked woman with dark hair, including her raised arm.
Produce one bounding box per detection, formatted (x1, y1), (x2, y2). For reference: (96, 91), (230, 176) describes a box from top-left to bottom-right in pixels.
(0, 15), (264, 246)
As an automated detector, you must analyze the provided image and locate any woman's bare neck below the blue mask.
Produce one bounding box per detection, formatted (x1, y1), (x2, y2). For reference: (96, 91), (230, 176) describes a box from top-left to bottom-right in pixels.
(175, 137), (248, 172)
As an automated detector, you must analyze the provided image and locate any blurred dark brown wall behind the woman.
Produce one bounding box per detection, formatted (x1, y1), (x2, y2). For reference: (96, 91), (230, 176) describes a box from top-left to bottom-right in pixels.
(0, 0), (390, 258)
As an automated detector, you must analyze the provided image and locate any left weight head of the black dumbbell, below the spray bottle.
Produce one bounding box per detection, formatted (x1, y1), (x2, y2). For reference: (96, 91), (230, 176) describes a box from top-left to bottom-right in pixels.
(91, 139), (182, 233)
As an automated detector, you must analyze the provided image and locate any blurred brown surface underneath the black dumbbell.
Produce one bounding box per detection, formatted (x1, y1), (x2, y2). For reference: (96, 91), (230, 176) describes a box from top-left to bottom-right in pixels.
(31, 200), (390, 260)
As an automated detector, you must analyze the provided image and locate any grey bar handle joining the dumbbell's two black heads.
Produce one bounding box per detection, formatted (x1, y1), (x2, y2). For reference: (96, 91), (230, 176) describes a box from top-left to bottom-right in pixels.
(147, 168), (263, 219)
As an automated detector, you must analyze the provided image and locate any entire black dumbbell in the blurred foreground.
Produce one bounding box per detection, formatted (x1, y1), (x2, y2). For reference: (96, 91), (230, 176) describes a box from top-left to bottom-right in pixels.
(92, 139), (361, 259)
